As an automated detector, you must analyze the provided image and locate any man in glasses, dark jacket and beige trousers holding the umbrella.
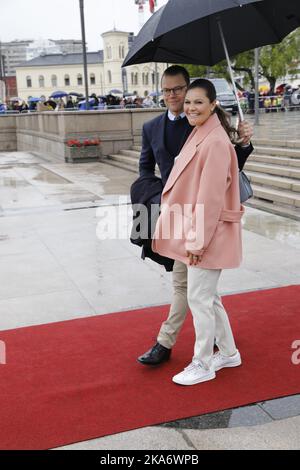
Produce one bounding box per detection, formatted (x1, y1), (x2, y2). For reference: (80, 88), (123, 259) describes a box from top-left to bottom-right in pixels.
(138, 65), (253, 365)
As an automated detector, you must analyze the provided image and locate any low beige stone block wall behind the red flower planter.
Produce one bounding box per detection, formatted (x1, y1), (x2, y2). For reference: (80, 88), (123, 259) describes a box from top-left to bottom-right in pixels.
(10, 109), (163, 161)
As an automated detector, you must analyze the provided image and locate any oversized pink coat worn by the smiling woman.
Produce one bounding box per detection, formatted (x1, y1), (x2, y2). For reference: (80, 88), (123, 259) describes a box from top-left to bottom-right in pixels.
(152, 114), (244, 269)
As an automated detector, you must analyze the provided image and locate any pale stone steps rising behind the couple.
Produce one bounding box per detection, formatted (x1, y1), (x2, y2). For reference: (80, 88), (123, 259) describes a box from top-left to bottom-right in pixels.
(103, 139), (300, 220)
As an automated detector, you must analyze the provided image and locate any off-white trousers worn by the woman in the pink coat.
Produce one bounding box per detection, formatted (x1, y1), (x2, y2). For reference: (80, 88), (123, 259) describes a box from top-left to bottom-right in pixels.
(187, 266), (237, 369)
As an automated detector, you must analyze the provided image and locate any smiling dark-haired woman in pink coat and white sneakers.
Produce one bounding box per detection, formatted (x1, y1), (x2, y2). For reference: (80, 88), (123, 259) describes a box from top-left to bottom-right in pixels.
(152, 79), (244, 385)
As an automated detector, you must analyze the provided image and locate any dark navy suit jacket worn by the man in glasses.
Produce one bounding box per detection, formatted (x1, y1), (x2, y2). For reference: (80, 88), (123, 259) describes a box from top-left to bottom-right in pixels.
(139, 112), (253, 185)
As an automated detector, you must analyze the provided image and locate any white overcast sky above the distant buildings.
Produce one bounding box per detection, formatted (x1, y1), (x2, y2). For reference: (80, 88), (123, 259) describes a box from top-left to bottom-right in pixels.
(0, 0), (167, 51)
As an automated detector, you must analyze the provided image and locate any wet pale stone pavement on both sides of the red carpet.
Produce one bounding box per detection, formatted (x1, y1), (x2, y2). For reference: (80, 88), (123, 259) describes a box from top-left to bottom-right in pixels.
(0, 113), (300, 450)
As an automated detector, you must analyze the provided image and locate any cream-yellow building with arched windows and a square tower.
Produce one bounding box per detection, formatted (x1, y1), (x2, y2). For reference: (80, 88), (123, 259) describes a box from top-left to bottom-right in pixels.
(16, 30), (167, 99)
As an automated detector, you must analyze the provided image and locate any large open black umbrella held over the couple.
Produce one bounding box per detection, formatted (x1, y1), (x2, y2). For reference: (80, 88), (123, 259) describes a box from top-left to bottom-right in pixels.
(123, 0), (300, 117)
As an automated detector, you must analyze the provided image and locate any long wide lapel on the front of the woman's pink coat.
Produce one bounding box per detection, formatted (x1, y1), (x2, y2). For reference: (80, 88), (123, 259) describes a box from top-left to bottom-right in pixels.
(163, 114), (221, 194)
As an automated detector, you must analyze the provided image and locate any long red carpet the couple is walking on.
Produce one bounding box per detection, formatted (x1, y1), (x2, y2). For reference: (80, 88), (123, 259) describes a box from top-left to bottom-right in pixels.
(0, 286), (300, 449)
